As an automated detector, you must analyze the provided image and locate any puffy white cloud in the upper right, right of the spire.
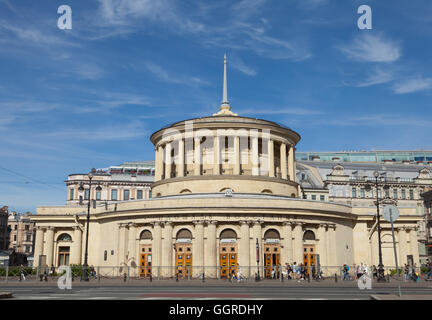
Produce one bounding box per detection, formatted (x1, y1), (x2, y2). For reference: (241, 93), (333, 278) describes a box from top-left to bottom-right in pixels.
(339, 33), (401, 62)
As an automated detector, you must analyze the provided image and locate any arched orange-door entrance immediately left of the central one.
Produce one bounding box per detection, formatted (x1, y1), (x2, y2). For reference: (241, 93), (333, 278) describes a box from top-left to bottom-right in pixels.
(175, 229), (192, 278)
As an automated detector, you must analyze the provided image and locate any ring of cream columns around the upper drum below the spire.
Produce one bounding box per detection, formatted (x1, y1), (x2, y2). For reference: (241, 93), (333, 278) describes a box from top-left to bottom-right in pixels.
(155, 134), (296, 181)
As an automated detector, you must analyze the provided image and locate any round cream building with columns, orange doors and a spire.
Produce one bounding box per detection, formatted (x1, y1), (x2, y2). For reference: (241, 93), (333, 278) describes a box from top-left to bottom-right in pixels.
(33, 57), (422, 277)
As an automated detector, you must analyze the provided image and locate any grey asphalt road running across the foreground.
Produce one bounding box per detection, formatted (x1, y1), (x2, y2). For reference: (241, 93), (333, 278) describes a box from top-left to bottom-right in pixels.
(0, 284), (432, 300)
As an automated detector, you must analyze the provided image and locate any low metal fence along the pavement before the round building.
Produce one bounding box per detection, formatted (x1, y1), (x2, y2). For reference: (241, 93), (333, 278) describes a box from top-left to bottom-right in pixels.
(0, 266), (427, 283)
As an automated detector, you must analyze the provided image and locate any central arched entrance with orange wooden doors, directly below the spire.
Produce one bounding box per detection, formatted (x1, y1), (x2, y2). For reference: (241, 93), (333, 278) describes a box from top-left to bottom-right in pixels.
(219, 229), (238, 278)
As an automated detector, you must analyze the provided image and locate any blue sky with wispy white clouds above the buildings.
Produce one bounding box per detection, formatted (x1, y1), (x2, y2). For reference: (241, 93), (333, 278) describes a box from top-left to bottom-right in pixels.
(0, 0), (432, 212)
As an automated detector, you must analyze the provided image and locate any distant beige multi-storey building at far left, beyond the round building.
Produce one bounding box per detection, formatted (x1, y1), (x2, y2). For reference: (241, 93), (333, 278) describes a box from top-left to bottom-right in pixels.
(8, 212), (35, 255)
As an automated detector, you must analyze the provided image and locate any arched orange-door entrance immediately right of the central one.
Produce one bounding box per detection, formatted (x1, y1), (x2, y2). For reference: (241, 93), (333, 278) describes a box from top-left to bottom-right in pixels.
(264, 229), (281, 279)
